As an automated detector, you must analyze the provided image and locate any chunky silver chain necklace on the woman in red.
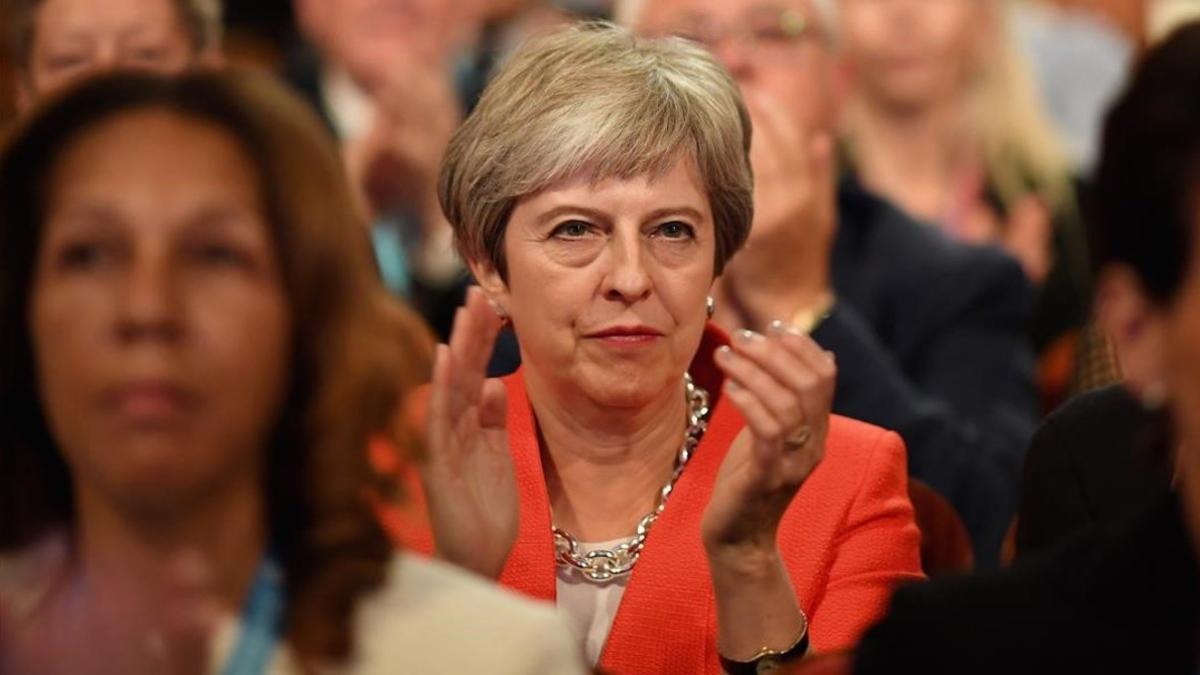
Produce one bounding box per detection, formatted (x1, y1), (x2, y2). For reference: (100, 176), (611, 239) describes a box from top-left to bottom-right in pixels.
(550, 374), (709, 584)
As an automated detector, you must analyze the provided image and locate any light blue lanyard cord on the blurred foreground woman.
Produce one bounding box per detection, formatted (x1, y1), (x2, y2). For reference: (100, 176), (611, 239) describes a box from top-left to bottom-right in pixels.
(221, 557), (284, 675)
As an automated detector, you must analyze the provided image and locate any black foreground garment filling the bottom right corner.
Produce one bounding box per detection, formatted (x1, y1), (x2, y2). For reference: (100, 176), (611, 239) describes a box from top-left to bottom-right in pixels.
(854, 487), (1198, 675)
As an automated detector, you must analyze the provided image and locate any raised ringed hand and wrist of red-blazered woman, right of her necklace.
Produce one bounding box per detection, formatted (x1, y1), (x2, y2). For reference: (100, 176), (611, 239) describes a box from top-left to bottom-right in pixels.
(701, 322), (838, 569)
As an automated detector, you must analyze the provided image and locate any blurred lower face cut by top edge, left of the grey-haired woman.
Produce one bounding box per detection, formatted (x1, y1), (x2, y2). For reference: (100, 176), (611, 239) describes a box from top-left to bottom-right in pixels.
(294, 0), (474, 89)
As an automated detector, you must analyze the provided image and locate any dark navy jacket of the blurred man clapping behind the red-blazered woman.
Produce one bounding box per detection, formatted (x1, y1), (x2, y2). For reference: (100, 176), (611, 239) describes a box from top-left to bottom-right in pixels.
(812, 179), (1037, 567)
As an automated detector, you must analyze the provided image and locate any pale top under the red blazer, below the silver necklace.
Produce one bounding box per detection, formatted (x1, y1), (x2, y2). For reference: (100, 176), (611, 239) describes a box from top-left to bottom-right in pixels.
(556, 537), (632, 665)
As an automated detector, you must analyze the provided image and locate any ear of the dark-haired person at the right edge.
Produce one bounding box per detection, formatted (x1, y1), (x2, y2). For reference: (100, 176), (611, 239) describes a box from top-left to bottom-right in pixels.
(1096, 265), (1165, 395)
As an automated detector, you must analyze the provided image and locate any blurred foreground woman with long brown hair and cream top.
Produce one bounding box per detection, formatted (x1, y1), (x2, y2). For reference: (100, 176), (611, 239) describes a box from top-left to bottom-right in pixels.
(0, 68), (575, 673)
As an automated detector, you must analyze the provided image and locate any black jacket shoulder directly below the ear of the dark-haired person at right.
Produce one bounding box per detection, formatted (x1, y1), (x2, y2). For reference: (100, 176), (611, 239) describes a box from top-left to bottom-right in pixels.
(1016, 386), (1171, 556)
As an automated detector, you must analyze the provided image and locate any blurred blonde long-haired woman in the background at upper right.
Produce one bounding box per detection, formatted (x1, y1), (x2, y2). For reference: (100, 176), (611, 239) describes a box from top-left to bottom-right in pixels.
(839, 0), (1090, 394)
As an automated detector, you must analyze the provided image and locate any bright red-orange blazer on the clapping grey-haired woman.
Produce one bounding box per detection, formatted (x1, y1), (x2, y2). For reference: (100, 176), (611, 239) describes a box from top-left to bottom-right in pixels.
(372, 324), (923, 675)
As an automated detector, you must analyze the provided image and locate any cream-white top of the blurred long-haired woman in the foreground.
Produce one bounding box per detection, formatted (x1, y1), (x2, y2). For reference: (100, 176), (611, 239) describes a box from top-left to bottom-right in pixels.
(0, 533), (586, 675)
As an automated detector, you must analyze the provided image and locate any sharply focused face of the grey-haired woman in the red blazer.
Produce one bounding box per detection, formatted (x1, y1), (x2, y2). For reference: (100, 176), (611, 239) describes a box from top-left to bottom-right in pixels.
(485, 161), (715, 406)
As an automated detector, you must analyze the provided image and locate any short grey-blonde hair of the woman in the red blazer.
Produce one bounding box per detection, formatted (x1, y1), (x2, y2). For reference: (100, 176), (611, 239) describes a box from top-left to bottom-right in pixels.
(438, 22), (754, 279)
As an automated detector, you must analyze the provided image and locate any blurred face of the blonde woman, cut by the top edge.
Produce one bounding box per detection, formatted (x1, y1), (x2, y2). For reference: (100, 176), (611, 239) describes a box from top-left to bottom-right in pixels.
(839, 0), (996, 109)
